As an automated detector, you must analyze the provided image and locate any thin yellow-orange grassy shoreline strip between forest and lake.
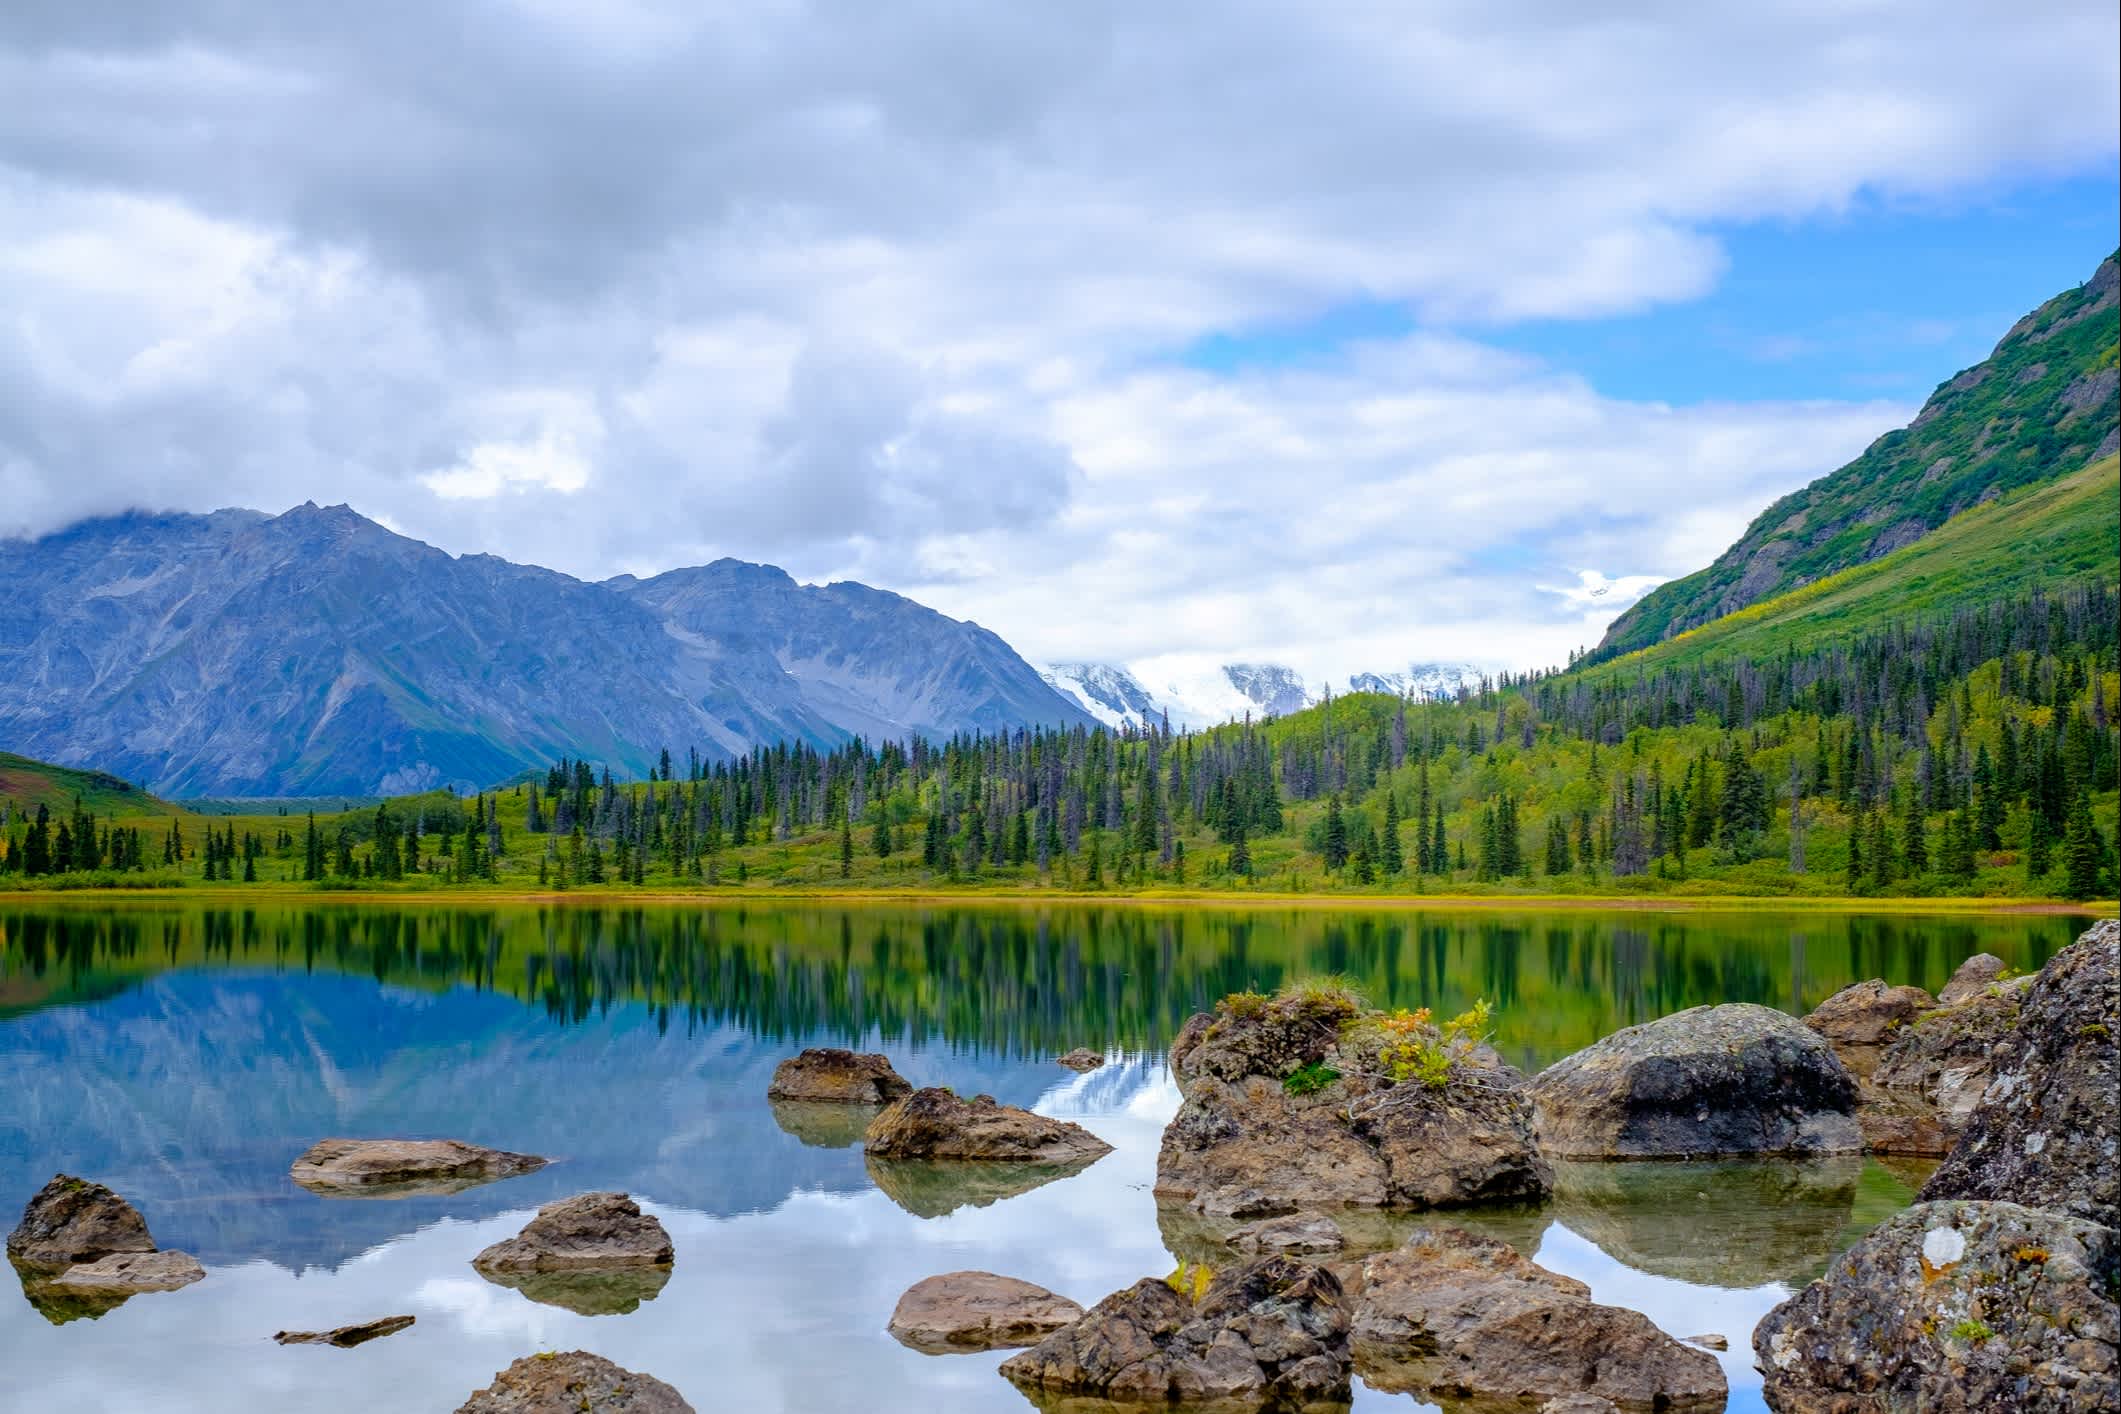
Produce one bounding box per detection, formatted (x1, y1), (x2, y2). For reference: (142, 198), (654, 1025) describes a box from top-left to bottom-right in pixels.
(0, 884), (2113, 918)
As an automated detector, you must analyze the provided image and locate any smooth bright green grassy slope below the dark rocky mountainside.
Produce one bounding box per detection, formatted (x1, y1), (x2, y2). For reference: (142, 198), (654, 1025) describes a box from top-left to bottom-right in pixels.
(1587, 456), (2121, 674)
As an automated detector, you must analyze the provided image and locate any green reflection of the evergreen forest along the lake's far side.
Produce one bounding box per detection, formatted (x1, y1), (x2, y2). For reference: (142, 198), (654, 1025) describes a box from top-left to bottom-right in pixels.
(0, 901), (2081, 1064)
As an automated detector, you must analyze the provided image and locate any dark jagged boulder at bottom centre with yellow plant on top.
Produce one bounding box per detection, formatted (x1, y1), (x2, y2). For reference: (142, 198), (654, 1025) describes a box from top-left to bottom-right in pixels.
(1001, 1257), (1349, 1408)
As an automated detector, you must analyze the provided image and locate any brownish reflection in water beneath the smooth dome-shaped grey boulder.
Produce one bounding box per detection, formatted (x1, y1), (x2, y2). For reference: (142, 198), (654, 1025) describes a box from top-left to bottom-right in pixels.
(1548, 1155), (1864, 1289)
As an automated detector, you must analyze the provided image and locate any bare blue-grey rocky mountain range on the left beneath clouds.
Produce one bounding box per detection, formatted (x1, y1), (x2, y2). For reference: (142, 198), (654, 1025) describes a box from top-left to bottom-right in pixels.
(0, 505), (1090, 797)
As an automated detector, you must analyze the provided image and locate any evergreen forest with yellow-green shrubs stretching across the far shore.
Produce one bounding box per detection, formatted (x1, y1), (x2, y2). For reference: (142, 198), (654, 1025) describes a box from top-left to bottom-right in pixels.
(0, 581), (2121, 899)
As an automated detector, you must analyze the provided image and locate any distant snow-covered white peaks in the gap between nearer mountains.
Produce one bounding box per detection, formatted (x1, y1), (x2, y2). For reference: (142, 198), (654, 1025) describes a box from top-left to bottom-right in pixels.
(1039, 664), (1480, 727)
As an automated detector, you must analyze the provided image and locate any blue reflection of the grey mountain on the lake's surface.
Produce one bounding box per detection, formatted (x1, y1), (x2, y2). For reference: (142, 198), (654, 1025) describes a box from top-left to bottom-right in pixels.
(0, 971), (1050, 1268)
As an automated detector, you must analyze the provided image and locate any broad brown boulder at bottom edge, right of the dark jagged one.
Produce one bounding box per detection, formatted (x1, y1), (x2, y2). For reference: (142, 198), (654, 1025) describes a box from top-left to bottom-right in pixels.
(1351, 1227), (1729, 1410)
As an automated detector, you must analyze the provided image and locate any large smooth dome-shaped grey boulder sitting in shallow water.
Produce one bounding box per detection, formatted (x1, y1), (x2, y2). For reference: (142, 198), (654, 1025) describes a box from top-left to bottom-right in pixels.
(1529, 1003), (1862, 1160)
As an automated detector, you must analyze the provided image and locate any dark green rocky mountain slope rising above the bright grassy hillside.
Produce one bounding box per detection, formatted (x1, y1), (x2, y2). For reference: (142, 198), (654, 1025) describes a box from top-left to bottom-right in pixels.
(1597, 257), (2121, 657)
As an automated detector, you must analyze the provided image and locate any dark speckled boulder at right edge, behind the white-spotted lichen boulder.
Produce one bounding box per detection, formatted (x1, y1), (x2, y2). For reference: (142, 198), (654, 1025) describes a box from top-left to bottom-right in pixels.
(1922, 918), (2121, 1227)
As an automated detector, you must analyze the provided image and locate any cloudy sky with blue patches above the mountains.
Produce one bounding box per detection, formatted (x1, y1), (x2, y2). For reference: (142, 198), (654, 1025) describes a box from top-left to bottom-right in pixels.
(0, 0), (2121, 683)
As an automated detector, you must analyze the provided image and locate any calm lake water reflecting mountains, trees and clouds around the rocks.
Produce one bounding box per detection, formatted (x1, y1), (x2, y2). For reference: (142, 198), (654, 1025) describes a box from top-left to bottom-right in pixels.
(0, 895), (2089, 1414)
